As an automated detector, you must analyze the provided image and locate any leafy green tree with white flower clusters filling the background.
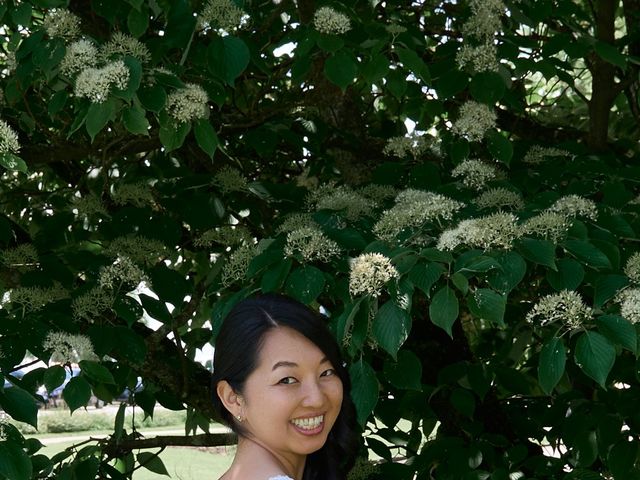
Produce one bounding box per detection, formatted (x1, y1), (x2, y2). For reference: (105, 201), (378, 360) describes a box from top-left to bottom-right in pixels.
(0, 0), (640, 480)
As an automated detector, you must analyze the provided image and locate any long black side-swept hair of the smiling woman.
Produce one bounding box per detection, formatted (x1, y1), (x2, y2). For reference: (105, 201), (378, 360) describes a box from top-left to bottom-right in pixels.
(212, 294), (358, 480)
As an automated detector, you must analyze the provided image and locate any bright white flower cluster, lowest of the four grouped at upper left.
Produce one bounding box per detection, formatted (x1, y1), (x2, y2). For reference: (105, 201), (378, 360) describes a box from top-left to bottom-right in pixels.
(75, 60), (130, 103)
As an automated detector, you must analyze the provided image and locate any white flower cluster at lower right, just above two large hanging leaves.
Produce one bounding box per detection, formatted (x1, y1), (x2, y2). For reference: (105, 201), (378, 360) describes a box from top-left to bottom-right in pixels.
(527, 290), (593, 329)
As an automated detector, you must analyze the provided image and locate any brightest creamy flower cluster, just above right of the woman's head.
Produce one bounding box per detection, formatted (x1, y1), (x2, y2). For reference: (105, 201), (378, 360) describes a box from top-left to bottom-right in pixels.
(349, 253), (400, 297)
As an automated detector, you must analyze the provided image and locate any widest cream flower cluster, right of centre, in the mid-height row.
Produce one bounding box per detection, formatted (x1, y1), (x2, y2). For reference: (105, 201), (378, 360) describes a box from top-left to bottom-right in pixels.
(437, 212), (522, 250)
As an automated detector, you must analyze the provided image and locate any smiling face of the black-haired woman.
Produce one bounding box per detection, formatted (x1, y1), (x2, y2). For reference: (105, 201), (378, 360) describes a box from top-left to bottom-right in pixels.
(236, 327), (343, 461)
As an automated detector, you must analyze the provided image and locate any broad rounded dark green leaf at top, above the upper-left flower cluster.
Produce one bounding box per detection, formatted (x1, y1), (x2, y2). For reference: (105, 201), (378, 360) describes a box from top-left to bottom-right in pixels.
(207, 35), (251, 85)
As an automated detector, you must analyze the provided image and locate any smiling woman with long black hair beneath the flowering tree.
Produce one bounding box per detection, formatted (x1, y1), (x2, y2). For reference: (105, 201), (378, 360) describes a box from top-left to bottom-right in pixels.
(213, 295), (357, 480)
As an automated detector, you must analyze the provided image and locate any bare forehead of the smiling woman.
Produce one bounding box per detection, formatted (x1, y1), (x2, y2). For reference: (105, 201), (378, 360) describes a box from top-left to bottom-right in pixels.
(258, 327), (325, 369)
